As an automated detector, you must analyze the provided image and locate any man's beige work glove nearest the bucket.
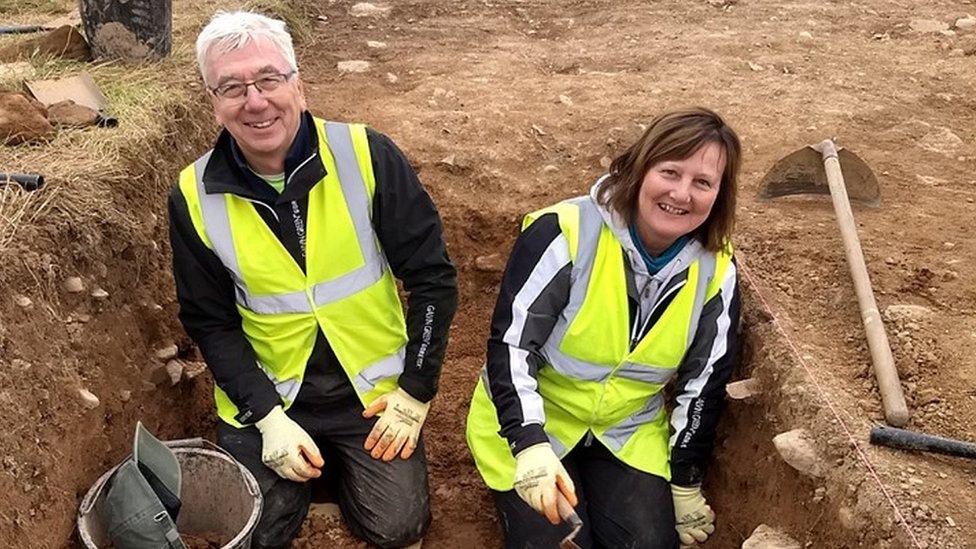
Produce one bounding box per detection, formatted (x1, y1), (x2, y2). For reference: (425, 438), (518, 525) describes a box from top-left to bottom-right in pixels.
(254, 405), (325, 482)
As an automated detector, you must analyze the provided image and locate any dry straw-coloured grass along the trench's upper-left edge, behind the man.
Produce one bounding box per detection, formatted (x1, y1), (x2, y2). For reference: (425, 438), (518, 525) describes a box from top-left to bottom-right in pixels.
(0, 0), (310, 284)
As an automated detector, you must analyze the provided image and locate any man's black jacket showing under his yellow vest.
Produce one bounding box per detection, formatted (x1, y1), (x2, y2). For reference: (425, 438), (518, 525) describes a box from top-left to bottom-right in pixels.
(169, 112), (457, 423)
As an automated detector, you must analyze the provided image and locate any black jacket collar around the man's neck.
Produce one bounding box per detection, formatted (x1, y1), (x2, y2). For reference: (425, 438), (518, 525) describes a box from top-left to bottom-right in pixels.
(203, 111), (327, 204)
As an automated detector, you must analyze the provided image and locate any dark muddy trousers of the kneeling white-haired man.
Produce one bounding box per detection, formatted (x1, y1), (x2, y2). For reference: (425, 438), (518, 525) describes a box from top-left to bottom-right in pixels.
(217, 396), (430, 549)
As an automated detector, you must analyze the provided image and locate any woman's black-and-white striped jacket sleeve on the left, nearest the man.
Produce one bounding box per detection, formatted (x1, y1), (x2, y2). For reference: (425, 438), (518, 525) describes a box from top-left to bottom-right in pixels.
(486, 214), (572, 455)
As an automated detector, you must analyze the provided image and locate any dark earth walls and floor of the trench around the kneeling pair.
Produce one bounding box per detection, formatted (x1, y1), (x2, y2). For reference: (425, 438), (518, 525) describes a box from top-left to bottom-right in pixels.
(0, 91), (902, 548)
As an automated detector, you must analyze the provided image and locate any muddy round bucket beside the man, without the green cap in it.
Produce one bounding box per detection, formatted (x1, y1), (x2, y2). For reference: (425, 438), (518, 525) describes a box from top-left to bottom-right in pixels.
(78, 438), (264, 549)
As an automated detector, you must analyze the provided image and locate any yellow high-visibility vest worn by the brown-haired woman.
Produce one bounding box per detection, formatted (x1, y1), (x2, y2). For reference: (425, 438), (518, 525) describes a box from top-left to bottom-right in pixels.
(467, 197), (732, 491)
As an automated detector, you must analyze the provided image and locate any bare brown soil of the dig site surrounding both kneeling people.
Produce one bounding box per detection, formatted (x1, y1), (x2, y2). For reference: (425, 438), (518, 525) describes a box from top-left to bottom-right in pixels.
(0, 0), (976, 548)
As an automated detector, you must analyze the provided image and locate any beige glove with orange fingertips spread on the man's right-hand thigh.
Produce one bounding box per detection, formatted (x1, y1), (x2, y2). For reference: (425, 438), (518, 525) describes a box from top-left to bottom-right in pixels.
(363, 387), (430, 461)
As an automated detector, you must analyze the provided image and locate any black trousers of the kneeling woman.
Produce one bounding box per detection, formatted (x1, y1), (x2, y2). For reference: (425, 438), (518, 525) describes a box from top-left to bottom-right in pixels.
(492, 439), (678, 549)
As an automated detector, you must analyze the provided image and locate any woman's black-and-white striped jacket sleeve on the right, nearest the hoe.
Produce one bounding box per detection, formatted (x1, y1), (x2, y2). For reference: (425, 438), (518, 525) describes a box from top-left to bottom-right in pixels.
(670, 261), (740, 486)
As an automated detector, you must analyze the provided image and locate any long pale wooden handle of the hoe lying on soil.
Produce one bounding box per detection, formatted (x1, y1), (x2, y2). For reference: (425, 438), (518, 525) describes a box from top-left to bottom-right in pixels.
(817, 139), (908, 427)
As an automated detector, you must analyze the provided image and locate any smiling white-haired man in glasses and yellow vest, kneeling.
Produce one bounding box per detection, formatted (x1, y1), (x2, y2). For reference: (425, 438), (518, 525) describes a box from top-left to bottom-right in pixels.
(169, 12), (457, 548)
